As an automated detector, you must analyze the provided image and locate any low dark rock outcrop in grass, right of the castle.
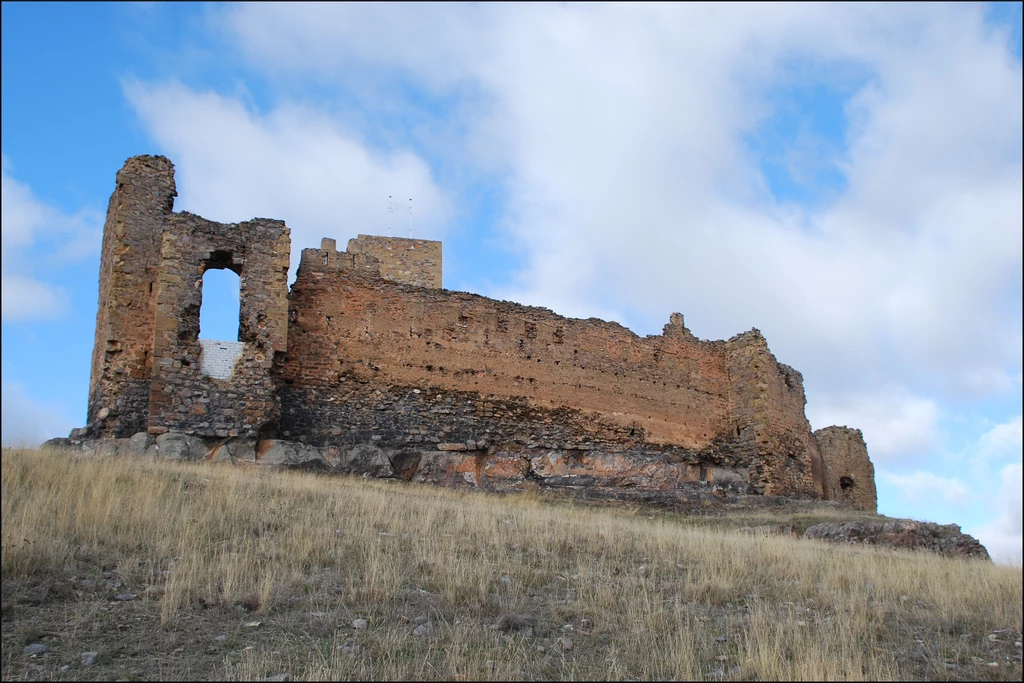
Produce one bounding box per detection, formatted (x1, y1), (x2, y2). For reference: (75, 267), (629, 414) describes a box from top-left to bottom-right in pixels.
(804, 519), (991, 560)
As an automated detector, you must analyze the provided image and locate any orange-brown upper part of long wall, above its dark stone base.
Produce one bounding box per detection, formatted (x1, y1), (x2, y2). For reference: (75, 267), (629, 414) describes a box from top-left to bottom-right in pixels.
(283, 242), (728, 449)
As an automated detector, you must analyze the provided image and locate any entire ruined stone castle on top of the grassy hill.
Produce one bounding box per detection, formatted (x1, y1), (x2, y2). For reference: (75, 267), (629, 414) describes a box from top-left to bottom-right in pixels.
(72, 156), (877, 511)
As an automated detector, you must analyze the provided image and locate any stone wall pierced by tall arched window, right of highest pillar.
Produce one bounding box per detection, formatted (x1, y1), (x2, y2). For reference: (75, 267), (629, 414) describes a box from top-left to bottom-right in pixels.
(148, 213), (291, 437)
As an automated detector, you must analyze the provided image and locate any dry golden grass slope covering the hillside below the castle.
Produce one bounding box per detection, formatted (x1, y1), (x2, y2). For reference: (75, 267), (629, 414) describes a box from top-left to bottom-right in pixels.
(2, 450), (1021, 680)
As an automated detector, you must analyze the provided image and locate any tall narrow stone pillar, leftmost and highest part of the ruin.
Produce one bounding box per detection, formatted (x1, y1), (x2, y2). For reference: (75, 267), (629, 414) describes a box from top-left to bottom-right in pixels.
(88, 156), (177, 438)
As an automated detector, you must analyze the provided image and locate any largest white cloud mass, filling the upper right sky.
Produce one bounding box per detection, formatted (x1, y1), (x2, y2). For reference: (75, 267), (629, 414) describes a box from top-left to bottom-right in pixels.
(211, 4), (1022, 411)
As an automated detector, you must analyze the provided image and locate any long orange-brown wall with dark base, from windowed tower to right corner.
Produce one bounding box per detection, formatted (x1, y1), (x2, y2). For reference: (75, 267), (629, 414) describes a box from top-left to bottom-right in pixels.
(280, 244), (818, 496)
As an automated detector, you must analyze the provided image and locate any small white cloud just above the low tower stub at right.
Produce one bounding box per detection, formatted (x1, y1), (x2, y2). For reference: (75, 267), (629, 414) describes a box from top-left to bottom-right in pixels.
(807, 386), (941, 464)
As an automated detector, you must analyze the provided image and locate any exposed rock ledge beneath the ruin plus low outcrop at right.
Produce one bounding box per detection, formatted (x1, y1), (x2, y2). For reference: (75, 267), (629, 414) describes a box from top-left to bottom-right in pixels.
(42, 432), (989, 560)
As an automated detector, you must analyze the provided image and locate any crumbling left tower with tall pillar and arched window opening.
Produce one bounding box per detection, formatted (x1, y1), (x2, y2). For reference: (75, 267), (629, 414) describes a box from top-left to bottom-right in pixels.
(88, 156), (291, 438)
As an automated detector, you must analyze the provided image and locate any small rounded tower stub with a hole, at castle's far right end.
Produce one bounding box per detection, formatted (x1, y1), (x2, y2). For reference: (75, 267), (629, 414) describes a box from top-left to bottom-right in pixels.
(814, 426), (878, 512)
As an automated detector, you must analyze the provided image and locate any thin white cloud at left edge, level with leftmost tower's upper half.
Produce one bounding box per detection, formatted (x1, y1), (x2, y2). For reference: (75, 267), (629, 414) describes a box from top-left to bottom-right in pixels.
(0, 155), (99, 322)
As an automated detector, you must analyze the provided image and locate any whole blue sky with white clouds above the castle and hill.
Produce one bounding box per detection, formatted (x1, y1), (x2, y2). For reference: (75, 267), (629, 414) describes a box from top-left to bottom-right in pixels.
(0, 2), (1022, 562)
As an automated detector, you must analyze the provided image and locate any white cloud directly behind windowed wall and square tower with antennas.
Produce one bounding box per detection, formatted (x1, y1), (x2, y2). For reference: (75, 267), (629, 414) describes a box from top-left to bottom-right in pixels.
(125, 82), (451, 282)
